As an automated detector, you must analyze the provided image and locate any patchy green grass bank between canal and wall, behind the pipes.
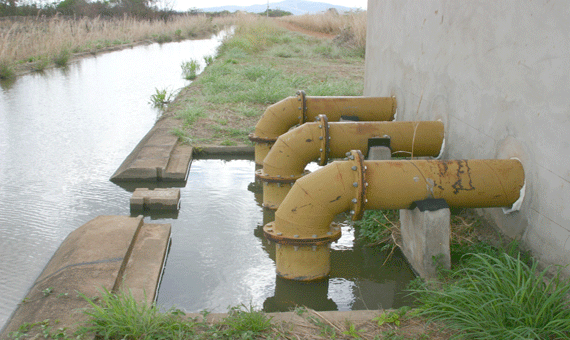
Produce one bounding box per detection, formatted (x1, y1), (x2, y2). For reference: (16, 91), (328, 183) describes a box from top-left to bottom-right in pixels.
(164, 16), (364, 146)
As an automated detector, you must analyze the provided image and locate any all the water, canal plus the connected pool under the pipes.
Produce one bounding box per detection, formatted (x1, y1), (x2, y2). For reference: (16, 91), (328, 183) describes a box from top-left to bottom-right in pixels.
(0, 31), (413, 325)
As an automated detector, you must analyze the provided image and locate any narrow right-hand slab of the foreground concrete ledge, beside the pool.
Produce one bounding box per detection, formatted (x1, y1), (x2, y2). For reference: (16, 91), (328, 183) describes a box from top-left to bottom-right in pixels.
(121, 224), (171, 303)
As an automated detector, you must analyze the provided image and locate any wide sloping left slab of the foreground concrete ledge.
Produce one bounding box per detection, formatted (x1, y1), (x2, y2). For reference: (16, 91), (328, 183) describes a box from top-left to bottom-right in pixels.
(1, 216), (143, 339)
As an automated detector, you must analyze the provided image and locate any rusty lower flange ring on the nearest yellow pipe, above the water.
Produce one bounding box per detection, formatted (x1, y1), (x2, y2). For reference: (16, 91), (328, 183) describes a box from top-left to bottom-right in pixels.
(263, 222), (341, 246)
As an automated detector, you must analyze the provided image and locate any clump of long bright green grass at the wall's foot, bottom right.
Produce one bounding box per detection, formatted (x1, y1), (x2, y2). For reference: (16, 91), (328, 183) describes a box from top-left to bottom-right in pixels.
(406, 247), (570, 339)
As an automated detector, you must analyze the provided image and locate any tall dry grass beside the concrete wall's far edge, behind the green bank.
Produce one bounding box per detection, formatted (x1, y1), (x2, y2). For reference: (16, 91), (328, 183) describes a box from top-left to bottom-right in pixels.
(279, 11), (366, 48)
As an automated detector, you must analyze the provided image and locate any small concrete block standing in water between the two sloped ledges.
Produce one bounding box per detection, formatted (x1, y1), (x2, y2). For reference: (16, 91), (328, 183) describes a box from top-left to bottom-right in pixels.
(130, 188), (180, 211)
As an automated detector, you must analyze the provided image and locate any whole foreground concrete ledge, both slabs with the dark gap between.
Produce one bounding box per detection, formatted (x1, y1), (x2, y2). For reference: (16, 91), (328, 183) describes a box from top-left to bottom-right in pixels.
(0, 216), (170, 339)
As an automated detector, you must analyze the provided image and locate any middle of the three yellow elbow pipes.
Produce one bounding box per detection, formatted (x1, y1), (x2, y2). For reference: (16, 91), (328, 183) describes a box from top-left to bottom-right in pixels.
(256, 119), (444, 209)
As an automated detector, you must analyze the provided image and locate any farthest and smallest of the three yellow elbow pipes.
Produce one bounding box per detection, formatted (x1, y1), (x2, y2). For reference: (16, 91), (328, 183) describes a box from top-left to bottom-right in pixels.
(249, 91), (396, 165)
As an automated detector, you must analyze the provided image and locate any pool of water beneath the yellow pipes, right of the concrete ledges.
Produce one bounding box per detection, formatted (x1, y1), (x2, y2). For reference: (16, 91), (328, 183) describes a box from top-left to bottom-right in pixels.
(157, 160), (413, 312)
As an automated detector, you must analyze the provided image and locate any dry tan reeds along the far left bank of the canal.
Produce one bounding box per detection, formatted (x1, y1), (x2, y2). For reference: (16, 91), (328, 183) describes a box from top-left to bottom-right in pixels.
(0, 15), (236, 79)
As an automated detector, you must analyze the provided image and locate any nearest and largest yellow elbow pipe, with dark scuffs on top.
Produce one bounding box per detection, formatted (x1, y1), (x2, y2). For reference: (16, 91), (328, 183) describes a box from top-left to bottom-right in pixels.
(264, 151), (525, 281)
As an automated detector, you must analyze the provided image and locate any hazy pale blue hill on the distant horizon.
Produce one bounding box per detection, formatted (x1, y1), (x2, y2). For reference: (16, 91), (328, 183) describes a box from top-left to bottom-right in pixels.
(200, 0), (357, 15)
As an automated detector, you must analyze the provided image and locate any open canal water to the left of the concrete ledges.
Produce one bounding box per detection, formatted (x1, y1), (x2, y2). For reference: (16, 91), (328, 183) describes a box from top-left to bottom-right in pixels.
(0, 33), (225, 327)
